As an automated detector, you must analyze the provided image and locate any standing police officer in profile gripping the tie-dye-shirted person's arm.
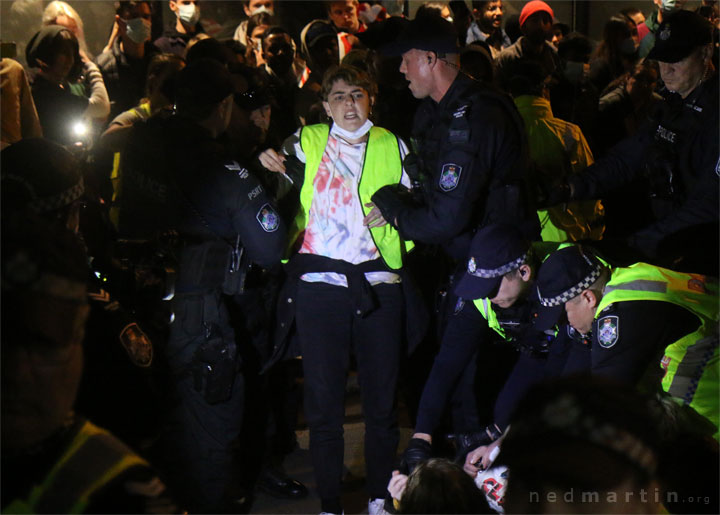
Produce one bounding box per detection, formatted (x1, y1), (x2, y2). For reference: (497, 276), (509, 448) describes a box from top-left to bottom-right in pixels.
(373, 15), (539, 262)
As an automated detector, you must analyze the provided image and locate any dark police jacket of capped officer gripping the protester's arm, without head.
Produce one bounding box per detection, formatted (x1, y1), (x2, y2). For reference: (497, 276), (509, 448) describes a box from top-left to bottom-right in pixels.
(390, 74), (539, 260)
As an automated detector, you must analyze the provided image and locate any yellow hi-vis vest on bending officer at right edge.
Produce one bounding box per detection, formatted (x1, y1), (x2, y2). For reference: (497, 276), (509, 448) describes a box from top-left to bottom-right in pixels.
(597, 263), (720, 438)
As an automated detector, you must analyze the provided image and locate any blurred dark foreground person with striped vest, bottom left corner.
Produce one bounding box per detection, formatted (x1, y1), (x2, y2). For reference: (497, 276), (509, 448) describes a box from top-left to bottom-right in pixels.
(0, 210), (177, 513)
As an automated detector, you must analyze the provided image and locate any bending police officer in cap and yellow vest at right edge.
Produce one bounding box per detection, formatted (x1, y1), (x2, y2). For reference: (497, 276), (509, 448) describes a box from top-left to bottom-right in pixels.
(536, 245), (720, 438)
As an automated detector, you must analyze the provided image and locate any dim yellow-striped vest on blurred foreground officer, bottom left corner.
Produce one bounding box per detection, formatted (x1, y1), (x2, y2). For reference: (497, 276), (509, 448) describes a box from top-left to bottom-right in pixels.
(3, 421), (147, 513)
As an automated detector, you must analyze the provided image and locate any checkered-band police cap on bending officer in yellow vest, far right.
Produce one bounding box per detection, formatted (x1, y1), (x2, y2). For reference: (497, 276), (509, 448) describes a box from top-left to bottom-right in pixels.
(535, 245), (604, 331)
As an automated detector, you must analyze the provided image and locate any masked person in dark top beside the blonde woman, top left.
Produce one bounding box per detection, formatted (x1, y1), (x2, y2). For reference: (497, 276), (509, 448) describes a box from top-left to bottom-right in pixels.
(97, 1), (158, 119)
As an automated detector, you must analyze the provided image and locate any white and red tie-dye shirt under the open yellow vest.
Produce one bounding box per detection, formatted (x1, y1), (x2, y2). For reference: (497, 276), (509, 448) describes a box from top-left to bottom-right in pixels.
(286, 124), (410, 286)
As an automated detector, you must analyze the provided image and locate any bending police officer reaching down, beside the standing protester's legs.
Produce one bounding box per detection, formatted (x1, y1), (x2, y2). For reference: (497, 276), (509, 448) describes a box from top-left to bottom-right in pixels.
(404, 224), (554, 474)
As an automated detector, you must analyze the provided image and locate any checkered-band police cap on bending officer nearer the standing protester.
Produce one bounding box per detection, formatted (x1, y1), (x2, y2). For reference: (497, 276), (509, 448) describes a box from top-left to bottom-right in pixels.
(455, 224), (530, 300)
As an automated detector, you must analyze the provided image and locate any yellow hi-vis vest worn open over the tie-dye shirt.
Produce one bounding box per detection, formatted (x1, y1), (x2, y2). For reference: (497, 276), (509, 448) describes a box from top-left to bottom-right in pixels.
(289, 124), (414, 270)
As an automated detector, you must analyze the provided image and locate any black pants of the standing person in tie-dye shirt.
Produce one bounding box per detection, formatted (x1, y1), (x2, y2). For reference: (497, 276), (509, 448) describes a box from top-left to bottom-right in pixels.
(295, 281), (404, 511)
